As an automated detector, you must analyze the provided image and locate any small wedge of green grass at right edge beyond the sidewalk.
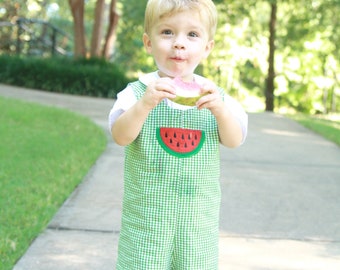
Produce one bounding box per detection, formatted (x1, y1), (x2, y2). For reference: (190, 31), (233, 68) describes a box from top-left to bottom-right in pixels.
(289, 114), (340, 146)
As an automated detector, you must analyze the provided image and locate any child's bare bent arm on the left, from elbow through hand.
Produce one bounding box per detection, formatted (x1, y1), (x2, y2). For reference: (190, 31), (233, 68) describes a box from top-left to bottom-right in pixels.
(111, 78), (175, 146)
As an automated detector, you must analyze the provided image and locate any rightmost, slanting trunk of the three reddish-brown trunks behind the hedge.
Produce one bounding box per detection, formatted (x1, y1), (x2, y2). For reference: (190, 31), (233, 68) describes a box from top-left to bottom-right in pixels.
(103, 0), (119, 59)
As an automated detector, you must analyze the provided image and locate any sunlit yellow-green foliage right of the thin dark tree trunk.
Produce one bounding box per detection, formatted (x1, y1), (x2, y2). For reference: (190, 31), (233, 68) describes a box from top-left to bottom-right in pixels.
(277, 0), (340, 113)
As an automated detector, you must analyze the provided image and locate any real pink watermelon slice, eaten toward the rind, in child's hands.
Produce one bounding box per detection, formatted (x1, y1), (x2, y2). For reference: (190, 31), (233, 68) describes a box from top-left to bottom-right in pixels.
(172, 78), (203, 106)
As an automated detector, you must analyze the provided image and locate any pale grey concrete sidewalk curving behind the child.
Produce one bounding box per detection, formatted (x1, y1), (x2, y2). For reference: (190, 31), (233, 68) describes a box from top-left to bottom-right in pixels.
(0, 85), (340, 270)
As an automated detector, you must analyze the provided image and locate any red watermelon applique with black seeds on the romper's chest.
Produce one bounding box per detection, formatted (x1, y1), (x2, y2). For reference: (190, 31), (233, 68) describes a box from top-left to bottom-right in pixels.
(157, 127), (205, 157)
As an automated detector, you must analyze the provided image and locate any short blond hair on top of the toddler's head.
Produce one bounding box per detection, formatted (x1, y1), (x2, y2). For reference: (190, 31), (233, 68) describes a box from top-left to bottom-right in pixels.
(144, 0), (217, 40)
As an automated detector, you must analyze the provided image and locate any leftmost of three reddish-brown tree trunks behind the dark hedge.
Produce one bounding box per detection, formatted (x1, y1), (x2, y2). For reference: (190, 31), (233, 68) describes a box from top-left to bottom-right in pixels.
(69, 0), (86, 57)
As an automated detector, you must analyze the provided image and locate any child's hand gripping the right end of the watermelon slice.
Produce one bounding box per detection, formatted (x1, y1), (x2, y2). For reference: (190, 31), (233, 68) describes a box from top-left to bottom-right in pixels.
(196, 81), (225, 116)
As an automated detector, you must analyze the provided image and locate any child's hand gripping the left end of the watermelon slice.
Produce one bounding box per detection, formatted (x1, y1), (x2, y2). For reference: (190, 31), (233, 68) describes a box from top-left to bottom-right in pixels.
(141, 78), (176, 110)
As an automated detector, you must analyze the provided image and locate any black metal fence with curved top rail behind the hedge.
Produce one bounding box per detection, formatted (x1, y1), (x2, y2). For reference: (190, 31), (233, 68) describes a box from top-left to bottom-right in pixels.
(0, 18), (73, 56)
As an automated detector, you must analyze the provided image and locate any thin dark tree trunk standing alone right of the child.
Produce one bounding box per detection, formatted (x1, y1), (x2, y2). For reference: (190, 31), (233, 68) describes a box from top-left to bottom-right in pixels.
(265, 2), (277, 111)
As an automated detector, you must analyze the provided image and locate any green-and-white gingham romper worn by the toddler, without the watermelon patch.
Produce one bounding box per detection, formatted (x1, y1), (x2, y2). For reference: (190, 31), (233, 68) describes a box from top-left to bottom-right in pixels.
(117, 81), (221, 270)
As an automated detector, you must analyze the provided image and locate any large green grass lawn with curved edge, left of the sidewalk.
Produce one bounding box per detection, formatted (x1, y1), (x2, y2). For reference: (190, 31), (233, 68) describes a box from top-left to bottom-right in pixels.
(0, 97), (106, 269)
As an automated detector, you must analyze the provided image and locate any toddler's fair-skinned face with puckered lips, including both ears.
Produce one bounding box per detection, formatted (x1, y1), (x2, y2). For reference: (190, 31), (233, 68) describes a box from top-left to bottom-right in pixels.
(143, 11), (214, 81)
